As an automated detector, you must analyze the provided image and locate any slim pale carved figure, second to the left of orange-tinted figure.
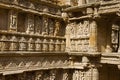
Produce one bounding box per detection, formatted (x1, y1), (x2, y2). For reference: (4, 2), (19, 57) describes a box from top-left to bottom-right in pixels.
(42, 17), (49, 35)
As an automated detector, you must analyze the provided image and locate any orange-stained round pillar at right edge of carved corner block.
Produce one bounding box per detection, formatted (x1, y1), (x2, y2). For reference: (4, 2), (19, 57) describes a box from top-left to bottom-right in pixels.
(89, 20), (97, 52)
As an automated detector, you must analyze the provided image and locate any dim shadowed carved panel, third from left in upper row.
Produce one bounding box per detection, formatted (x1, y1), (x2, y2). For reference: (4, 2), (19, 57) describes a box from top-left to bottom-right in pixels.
(35, 16), (43, 34)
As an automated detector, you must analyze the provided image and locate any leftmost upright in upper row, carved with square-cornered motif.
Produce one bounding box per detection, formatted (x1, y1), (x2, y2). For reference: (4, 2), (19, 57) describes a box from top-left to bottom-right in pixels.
(8, 10), (17, 31)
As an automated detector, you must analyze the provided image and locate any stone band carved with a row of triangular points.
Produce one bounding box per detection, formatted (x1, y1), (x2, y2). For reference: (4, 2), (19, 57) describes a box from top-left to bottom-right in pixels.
(0, 56), (69, 71)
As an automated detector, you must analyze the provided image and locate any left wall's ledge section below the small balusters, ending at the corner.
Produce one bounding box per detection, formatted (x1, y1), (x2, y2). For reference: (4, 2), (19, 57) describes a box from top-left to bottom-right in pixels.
(0, 51), (69, 57)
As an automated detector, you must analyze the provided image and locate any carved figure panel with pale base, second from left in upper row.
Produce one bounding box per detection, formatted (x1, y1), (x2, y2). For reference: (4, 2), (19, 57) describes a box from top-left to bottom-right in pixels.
(26, 14), (34, 34)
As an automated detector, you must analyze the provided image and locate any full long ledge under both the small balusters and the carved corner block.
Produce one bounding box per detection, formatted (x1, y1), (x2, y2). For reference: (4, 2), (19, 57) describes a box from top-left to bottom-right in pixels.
(0, 51), (101, 57)
